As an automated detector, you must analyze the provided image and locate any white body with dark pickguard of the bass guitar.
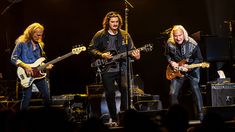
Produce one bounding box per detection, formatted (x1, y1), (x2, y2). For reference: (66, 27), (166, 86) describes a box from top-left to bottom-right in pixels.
(17, 57), (46, 88)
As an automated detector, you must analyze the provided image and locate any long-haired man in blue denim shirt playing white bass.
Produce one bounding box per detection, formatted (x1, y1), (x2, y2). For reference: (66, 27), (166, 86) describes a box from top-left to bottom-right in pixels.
(11, 23), (53, 110)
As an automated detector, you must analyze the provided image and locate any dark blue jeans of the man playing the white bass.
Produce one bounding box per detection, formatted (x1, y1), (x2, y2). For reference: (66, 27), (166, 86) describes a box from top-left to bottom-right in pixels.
(20, 79), (50, 110)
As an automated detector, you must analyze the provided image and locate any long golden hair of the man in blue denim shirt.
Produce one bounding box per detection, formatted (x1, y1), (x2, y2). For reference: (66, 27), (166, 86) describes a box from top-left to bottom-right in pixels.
(15, 22), (45, 48)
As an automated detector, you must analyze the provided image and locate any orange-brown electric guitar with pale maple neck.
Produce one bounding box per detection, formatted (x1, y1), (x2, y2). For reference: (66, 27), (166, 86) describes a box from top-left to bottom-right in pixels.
(166, 60), (210, 80)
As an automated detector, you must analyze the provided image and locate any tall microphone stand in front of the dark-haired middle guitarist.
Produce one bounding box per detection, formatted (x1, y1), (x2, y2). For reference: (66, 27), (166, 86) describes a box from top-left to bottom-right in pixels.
(125, 0), (134, 109)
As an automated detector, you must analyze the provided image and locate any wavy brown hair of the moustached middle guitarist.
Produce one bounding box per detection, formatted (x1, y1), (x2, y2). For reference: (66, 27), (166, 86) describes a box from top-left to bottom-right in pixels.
(102, 11), (123, 30)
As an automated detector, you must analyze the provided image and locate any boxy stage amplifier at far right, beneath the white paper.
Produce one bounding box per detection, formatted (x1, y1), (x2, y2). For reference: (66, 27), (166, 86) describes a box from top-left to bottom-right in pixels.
(208, 83), (235, 106)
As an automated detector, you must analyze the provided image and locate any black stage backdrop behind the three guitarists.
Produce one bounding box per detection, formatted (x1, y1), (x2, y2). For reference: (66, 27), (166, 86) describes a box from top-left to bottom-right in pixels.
(0, 0), (235, 107)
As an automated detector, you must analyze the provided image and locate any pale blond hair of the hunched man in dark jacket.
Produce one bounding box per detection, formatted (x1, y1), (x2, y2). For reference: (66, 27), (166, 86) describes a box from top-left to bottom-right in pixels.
(168, 25), (189, 44)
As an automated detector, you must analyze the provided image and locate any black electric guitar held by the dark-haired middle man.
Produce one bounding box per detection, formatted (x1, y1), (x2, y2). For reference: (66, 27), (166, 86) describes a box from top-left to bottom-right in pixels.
(91, 44), (153, 72)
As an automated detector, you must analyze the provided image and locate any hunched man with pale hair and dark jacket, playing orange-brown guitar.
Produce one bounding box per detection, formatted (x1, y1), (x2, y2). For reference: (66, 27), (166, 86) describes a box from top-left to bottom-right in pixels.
(165, 25), (203, 120)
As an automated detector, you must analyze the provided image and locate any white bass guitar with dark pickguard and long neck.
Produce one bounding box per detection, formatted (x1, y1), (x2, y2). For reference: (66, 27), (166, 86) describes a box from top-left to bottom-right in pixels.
(17, 46), (86, 88)
